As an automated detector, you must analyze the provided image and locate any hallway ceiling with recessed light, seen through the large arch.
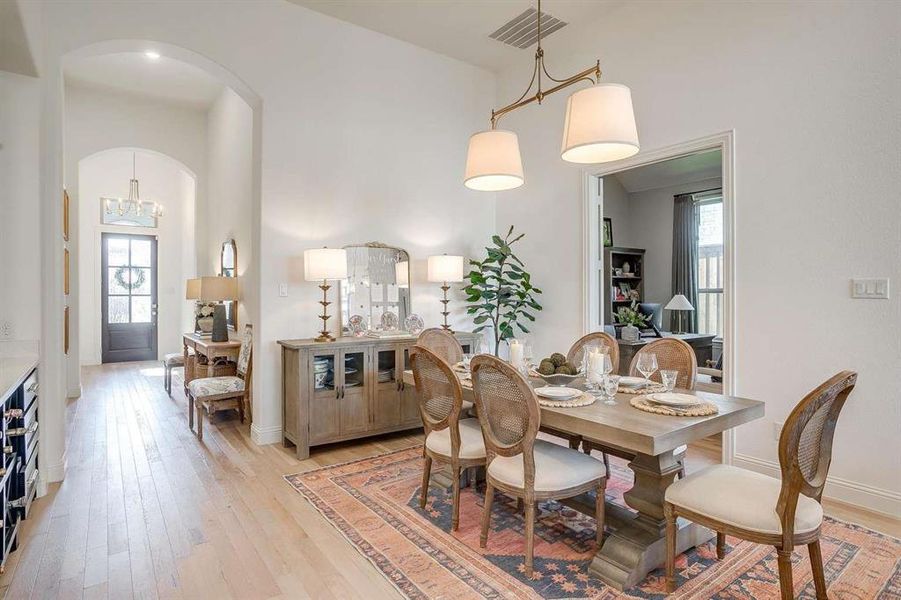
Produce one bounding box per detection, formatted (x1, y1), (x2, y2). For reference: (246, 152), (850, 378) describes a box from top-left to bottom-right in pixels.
(65, 52), (224, 108)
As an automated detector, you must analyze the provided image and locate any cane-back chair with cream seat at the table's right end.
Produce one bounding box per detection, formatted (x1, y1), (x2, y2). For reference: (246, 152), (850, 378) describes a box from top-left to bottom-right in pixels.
(663, 371), (857, 600)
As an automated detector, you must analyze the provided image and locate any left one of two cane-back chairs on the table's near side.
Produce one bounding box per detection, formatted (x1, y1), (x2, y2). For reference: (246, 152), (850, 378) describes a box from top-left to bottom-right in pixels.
(410, 346), (485, 530)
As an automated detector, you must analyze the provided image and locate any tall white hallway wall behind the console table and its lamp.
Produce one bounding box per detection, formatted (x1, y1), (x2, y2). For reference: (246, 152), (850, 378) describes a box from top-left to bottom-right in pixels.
(197, 88), (253, 333)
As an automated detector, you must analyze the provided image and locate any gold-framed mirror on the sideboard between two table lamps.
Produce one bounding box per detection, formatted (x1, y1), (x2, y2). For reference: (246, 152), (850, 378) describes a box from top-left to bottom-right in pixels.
(340, 242), (413, 335)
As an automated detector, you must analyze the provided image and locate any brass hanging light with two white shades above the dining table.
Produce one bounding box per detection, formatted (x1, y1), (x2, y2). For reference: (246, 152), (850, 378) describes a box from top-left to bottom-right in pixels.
(463, 0), (639, 192)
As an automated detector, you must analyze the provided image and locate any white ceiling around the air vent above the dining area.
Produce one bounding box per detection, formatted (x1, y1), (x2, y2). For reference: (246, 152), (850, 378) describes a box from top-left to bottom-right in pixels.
(289, 0), (613, 71)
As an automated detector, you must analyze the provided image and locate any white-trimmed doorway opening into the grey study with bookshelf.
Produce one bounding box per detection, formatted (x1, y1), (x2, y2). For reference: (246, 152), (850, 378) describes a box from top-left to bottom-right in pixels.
(583, 132), (736, 464)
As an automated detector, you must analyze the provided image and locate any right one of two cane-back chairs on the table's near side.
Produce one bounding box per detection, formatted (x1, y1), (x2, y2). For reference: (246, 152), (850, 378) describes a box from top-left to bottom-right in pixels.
(472, 354), (607, 577)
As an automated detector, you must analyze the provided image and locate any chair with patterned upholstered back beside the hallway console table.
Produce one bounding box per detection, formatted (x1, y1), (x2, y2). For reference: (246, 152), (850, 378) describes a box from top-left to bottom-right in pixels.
(188, 324), (253, 439)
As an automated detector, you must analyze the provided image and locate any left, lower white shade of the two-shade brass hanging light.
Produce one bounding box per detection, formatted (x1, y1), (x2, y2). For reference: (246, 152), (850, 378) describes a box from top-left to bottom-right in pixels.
(463, 129), (524, 192)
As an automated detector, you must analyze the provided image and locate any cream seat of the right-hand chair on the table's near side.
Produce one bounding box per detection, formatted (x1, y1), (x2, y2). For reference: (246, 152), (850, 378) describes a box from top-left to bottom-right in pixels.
(488, 440), (607, 492)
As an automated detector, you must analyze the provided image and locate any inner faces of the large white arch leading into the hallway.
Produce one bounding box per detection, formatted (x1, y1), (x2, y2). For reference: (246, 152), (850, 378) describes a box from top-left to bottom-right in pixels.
(39, 39), (262, 495)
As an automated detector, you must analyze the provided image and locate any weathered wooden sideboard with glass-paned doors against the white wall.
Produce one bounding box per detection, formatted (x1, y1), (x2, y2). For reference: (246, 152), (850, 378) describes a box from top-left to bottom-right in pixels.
(278, 332), (481, 458)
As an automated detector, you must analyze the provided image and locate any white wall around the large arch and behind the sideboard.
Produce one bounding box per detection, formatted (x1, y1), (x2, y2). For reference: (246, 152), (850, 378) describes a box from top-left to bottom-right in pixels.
(29, 0), (494, 454)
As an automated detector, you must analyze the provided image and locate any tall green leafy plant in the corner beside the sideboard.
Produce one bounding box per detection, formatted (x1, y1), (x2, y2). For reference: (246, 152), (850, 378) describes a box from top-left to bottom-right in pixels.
(463, 226), (541, 356)
